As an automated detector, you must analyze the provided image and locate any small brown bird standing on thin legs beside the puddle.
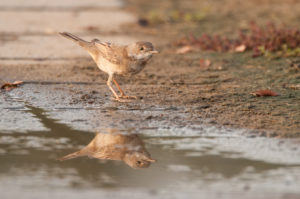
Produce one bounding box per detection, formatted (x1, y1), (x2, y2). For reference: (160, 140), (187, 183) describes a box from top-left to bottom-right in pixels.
(59, 32), (158, 102)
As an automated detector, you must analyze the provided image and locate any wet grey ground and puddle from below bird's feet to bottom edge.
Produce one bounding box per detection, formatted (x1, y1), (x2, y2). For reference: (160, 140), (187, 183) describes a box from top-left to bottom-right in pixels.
(0, 84), (300, 198)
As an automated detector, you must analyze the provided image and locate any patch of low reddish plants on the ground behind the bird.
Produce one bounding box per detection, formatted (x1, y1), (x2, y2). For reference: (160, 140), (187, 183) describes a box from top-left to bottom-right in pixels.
(176, 22), (300, 57)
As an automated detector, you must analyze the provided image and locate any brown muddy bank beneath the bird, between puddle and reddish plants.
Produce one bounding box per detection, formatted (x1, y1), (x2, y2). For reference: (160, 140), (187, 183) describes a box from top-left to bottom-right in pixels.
(3, 49), (300, 137)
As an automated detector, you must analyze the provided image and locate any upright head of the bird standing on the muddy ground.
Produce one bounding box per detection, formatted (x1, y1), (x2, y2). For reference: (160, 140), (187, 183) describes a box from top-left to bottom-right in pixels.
(127, 41), (158, 61)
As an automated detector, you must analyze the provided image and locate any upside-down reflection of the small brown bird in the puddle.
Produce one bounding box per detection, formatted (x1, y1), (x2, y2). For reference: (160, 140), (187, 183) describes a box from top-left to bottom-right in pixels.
(57, 129), (156, 169)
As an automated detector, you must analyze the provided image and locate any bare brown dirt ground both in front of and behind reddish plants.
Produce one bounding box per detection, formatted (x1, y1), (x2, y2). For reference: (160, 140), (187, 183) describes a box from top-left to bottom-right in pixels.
(1, 0), (300, 137)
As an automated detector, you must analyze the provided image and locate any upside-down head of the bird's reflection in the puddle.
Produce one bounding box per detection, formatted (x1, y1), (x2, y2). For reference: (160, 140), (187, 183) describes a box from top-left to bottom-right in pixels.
(123, 152), (156, 169)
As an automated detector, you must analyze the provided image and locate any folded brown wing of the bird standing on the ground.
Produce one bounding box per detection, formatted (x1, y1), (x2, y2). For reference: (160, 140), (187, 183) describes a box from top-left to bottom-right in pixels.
(94, 40), (124, 65)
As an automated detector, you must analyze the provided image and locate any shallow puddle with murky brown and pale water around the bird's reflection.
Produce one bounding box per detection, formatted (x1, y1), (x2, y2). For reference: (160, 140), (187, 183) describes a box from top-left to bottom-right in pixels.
(0, 102), (300, 198)
